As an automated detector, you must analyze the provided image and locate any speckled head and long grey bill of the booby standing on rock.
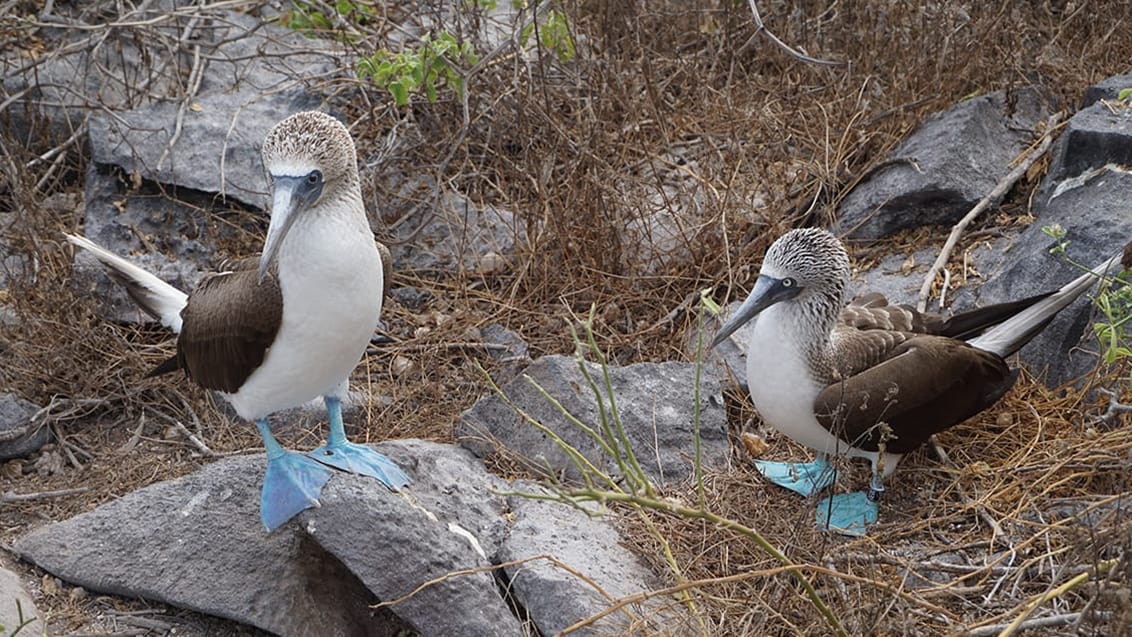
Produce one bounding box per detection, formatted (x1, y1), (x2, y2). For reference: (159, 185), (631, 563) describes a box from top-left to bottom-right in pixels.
(259, 111), (359, 281)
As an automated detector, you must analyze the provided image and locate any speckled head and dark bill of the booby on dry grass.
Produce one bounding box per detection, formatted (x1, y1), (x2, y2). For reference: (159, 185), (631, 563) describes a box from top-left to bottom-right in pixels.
(711, 227), (849, 347)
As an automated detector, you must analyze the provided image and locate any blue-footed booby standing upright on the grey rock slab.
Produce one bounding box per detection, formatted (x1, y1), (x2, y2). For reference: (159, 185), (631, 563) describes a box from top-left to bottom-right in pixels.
(67, 112), (409, 531)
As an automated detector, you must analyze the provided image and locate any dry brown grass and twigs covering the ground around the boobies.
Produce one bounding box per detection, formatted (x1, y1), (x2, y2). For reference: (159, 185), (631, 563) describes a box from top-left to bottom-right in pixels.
(0, 0), (1132, 635)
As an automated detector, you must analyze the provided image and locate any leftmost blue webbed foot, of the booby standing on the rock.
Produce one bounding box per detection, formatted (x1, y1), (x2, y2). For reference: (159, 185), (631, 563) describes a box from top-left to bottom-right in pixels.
(256, 420), (334, 533)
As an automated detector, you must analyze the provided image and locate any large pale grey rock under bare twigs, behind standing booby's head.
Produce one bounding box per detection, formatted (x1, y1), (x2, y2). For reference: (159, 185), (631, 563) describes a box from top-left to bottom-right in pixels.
(0, 8), (343, 208)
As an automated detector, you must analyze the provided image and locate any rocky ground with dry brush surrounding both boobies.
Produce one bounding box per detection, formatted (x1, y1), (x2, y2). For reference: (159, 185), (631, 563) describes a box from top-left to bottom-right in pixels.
(0, 0), (1132, 635)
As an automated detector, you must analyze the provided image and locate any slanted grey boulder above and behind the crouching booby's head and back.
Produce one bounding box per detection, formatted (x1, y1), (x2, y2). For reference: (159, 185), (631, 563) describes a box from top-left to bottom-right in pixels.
(835, 88), (1047, 239)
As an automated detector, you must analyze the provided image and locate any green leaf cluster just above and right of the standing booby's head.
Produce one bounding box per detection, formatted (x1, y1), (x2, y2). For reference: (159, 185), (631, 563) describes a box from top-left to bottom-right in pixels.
(358, 32), (479, 106)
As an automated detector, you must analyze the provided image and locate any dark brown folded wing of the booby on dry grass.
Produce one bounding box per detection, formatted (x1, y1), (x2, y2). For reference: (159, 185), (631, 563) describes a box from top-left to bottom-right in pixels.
(814, 332), (1017, 454)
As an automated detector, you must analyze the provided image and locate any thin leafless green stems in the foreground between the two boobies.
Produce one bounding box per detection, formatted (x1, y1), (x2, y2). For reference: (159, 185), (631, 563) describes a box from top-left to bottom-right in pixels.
(481, 303), (848, 636)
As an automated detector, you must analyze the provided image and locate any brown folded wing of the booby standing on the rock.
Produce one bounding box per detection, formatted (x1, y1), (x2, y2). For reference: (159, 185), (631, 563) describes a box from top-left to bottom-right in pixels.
(151, 268), (283, 393)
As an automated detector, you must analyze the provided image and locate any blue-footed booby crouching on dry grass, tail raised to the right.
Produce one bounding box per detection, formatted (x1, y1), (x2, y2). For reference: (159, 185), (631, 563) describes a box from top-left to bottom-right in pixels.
(711, 229), (1118, 535)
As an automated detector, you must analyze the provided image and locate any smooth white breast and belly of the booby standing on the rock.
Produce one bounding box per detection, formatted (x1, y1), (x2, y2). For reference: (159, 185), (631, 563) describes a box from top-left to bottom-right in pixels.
(229, 204), (384, 420)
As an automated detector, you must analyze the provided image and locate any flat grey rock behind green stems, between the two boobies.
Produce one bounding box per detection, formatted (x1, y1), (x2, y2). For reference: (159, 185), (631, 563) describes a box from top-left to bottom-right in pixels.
(456, 355), (730, 483)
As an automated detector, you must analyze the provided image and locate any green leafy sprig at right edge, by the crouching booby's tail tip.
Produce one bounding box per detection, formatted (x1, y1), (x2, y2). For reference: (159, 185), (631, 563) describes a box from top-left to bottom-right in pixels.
(1041, 224), (1132, 373)
